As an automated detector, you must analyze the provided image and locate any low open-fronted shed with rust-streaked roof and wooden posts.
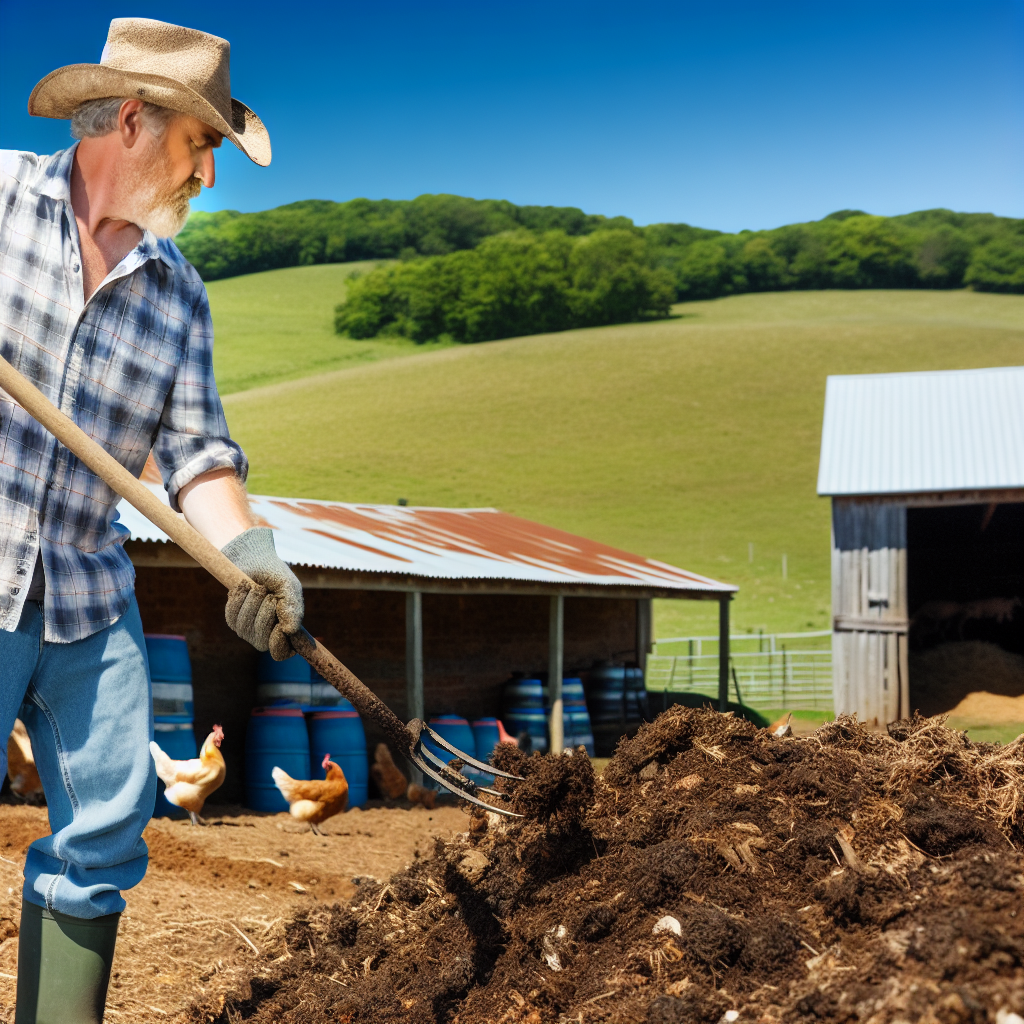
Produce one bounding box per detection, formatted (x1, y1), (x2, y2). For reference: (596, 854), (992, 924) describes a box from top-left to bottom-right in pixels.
(119, 462), (736, 800)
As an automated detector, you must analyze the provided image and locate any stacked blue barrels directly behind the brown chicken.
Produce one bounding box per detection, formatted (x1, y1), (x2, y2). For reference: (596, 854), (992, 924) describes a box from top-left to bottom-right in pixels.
(246, 654), (370, 811)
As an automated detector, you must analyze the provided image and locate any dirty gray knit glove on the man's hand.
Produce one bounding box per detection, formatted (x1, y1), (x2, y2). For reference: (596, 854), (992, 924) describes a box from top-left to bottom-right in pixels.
(220, 526), (303, 662)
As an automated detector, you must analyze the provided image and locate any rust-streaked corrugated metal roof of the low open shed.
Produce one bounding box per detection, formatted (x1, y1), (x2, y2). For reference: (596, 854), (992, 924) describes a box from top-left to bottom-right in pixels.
(118, 462), (736, 593)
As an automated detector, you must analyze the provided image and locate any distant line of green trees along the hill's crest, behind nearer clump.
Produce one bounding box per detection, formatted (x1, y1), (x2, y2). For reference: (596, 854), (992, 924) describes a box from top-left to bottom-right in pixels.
(177, 196), (1024, 301)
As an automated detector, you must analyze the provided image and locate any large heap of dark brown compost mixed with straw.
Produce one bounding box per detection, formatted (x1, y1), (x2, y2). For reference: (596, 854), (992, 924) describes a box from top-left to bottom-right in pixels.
(193, 707), (1024, 1024)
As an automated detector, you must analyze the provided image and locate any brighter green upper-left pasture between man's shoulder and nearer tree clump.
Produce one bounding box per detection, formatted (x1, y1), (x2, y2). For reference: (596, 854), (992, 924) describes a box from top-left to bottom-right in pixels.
(207, 260), (441, 394)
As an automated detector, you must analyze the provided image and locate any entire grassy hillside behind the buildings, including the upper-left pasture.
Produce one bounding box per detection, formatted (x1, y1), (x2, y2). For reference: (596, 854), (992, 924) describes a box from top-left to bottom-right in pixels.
(211, 266), (1024, 636)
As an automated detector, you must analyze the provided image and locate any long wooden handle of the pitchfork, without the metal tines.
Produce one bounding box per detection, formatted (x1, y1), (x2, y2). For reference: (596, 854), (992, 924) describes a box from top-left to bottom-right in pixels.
(0, 355), (423, 757)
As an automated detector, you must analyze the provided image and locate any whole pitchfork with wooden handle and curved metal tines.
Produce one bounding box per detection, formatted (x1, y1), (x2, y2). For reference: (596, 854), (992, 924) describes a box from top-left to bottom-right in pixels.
(0, 356), (522, 817)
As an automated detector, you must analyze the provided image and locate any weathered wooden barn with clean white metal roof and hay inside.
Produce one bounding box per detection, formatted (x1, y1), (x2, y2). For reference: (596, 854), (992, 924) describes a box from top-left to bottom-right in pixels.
(818, 367), (1024, 726)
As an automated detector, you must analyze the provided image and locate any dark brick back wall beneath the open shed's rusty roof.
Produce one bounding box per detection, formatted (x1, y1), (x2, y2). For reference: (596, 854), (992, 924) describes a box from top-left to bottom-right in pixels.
(136, 567), (636, 802)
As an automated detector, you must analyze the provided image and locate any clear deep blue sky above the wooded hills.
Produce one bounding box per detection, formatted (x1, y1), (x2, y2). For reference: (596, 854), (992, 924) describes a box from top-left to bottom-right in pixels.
(0, 0), (1024, 230)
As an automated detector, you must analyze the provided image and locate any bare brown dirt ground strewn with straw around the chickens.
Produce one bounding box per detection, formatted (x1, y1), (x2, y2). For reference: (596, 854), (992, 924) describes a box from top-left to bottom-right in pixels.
(0, 804), (466, 1024)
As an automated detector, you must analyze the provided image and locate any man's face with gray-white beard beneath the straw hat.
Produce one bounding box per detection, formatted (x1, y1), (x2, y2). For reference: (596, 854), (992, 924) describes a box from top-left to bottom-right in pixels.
(121, 114), (223, 238)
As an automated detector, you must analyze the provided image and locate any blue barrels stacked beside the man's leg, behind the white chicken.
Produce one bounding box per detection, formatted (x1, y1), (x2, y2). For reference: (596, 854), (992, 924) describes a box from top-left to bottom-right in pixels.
(144, 633), (199, 818)
